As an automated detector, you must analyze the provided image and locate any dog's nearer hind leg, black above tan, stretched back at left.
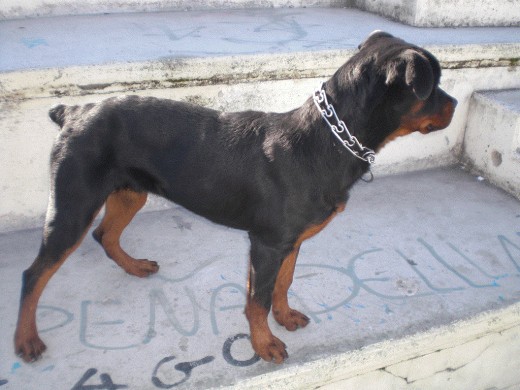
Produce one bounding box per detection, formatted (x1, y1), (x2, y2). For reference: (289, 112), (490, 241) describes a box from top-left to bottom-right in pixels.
(14, 187), (103, 362)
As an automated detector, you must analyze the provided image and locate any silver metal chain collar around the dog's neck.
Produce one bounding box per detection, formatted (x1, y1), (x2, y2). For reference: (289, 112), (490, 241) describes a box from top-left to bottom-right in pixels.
(313, 83), (375, 164)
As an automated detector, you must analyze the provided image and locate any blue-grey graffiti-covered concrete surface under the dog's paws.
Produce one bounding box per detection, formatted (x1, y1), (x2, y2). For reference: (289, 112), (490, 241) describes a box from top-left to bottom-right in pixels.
(0, 167), (520, 390)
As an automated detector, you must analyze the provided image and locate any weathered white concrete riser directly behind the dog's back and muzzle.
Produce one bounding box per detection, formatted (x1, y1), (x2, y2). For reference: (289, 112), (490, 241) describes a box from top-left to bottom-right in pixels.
(0, 45), (520, 235)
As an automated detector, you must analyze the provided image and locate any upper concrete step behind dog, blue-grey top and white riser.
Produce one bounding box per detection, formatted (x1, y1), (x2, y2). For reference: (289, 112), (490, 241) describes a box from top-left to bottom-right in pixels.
(0, 9), (520, 231)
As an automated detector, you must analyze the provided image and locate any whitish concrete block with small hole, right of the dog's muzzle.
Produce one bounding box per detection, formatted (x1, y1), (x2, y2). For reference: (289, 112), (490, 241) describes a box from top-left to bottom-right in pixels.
(463, 89), (520, 198)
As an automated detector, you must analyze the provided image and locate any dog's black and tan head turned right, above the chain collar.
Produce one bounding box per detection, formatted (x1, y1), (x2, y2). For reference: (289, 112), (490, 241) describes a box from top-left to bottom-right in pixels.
(333, 31), (457, 149)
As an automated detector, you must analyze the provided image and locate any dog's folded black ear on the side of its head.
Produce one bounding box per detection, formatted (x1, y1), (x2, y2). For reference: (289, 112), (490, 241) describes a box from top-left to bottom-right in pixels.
(386, 49), (435, 100)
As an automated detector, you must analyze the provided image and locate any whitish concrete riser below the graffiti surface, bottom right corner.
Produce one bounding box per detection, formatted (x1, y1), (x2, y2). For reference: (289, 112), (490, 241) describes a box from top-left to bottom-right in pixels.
(229, 304), (520, 390)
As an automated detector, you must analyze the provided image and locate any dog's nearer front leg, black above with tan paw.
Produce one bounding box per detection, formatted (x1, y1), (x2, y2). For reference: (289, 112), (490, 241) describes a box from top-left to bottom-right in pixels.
(245, 236), (289, 364)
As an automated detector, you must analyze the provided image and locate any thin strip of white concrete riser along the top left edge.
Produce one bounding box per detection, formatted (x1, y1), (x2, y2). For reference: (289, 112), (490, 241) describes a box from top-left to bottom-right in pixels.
(0, 0), (347, 19)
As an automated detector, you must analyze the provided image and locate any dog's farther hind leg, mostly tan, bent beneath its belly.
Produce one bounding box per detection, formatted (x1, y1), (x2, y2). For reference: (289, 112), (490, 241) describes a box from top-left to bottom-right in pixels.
(93, 190), (159, 277)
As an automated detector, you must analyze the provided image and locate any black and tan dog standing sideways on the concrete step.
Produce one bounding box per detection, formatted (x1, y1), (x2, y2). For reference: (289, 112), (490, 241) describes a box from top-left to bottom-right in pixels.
(15, 32), (456, 363)
